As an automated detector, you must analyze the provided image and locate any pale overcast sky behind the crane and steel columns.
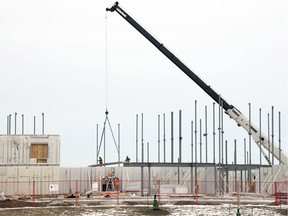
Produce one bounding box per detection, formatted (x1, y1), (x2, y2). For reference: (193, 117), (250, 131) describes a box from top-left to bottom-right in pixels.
(0, 0), (288, 166)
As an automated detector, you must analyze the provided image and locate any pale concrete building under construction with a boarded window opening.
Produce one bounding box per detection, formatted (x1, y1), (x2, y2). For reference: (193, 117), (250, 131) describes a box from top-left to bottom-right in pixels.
(0, 125), (288, 196)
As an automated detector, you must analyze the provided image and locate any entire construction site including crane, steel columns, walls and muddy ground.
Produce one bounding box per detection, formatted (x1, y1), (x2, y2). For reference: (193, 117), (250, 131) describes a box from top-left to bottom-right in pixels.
(0, 2), (288, 216)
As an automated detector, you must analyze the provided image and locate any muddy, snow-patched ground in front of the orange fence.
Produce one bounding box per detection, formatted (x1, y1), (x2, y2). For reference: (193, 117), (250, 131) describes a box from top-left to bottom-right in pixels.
(0, 195), (287, 216)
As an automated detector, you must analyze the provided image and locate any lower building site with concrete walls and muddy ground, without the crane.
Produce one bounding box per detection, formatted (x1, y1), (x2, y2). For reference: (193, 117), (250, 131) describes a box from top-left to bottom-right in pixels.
(0, 135), (287, 215)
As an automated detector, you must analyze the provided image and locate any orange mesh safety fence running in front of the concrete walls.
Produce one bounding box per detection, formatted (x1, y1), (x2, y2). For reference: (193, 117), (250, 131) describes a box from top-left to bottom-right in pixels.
(0, 176), (276, 205)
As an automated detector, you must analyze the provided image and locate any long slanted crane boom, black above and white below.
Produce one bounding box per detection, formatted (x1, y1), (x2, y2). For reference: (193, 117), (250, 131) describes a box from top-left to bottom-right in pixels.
(106, 2), (288, 165)
